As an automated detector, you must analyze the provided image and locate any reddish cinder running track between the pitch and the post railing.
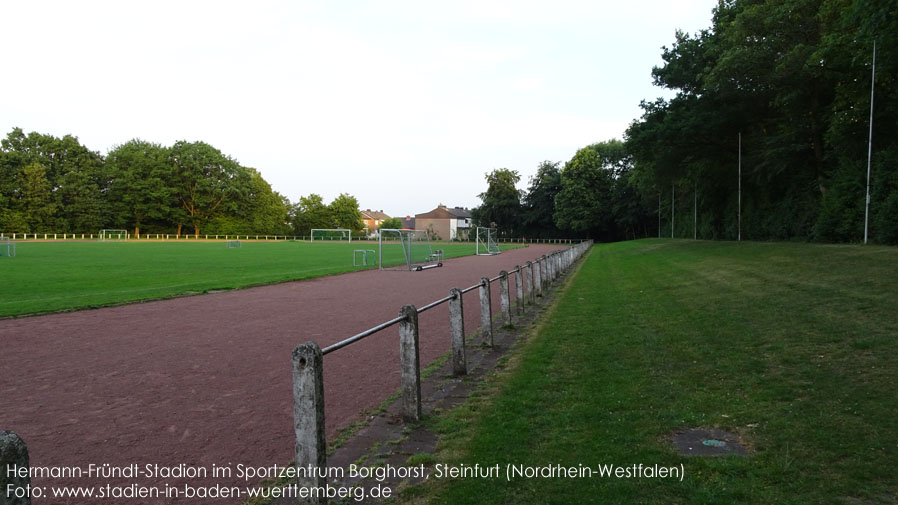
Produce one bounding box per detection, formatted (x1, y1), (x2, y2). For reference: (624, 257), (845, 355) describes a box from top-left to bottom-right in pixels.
(0, 245), (559, 504)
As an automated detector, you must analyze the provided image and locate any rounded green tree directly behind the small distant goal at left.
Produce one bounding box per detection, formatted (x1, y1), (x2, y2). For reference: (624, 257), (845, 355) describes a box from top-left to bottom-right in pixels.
(106, 139), (176, 237)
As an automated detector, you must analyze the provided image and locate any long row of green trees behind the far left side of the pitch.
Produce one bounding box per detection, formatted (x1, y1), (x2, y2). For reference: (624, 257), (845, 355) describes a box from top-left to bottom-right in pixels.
(0, 128), (362, 235)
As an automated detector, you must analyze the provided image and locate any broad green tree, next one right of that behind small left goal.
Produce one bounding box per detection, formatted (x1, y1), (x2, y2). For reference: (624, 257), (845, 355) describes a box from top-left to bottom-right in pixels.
(170, 141), (250, 235)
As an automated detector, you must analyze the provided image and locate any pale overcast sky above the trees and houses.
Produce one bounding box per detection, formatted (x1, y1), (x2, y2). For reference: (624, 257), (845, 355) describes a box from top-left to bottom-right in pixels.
(0, 0), (716, 216)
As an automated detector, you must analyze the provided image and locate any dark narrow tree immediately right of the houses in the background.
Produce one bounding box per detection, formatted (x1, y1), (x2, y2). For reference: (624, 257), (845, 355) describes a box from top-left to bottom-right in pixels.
(471, 168), (522, 235)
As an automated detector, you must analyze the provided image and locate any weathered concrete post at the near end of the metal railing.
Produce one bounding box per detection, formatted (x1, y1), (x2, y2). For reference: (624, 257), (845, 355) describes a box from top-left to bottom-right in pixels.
(293, 342), (327, 505)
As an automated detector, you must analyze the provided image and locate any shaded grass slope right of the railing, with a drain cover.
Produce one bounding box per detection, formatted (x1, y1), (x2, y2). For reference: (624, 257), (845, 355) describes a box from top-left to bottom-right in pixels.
(407, 240), (898, 504)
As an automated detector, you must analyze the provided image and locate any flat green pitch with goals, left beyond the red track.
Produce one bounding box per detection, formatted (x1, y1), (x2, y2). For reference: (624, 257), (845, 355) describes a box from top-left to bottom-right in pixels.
(0, 241), (504, 317)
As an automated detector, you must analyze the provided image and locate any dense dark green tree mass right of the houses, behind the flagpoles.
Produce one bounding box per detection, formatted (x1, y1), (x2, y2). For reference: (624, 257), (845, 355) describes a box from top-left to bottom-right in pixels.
(474, 0), (898, 244)
